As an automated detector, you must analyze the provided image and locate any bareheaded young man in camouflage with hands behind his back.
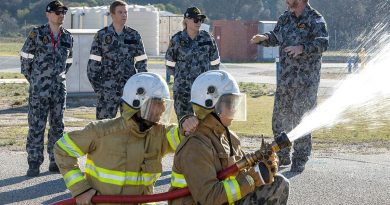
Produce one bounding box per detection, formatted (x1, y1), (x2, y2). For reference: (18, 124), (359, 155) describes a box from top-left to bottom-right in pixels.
(87, 1), (147, 119)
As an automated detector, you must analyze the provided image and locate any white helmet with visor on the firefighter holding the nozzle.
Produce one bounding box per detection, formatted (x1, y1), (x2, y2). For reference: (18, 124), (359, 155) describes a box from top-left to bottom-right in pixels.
(191, 70), (246, 121)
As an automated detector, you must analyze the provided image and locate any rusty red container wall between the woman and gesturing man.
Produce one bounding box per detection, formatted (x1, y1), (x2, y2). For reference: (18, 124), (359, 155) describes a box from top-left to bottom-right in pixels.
(213, 20), (258, 62)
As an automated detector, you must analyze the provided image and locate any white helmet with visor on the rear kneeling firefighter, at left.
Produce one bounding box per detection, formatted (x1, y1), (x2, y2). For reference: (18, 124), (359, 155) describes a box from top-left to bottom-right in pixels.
(122, 72), (173, 124)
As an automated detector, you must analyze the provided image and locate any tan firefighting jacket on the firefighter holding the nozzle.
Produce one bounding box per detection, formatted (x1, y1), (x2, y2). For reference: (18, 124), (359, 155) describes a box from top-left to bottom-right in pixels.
(169, 114), (255, 205)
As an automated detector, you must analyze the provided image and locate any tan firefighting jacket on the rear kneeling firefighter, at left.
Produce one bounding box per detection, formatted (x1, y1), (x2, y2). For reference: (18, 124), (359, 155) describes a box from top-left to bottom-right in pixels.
(54, 117), (181, 197)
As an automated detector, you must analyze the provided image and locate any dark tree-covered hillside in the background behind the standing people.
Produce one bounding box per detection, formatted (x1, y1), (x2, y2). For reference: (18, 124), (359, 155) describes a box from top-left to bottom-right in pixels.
(0, 0), (390, 50)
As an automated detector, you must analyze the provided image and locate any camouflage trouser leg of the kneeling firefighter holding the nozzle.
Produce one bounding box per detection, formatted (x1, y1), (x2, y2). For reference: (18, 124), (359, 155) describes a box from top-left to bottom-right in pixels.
(234, 175), (290, 205)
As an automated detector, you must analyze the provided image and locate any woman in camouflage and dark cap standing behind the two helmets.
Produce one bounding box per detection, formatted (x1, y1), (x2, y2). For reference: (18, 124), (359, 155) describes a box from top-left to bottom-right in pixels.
(165, 7), (220, 121)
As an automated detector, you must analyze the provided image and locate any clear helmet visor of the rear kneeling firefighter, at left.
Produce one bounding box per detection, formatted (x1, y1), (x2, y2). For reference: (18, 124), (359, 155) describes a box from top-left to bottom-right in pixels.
(141, 98), (173, 124)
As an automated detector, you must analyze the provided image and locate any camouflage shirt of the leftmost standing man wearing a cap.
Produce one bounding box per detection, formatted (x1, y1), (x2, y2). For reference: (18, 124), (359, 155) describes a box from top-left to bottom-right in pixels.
(20, 24), (73, 96)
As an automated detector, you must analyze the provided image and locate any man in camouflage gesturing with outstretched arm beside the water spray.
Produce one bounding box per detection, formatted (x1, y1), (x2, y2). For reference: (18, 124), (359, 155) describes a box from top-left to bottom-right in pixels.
(251, 0), (329, 172)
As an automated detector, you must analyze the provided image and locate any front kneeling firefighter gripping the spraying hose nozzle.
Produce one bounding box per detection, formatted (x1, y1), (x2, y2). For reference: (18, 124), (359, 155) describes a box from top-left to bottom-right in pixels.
(169, 70), (289, 205)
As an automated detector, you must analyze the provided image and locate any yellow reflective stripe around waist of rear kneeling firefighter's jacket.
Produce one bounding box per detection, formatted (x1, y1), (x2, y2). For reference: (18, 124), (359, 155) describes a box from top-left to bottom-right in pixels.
(85, 159), (161, 186)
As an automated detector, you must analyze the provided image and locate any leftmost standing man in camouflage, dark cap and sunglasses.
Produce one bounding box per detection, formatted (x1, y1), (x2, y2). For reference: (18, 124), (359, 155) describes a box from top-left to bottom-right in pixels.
(20, 1), (73, 177)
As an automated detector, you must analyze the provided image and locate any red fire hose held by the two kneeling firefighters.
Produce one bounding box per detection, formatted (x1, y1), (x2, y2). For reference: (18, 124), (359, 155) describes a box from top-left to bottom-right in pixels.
(52, 164), (239, 205)
